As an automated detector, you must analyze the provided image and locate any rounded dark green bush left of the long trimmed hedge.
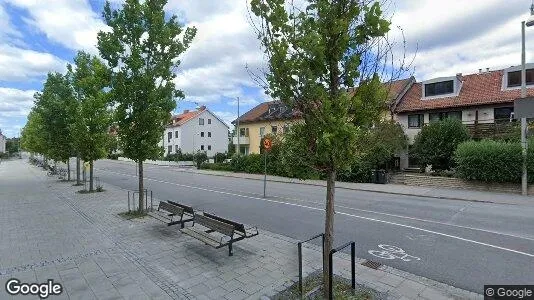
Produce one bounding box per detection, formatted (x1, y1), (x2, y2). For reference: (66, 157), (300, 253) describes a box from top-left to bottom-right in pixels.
(412, 119), (469, 170)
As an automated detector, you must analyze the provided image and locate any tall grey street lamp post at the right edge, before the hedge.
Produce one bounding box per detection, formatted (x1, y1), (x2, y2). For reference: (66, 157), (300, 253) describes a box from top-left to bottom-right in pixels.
(521, 2), (534, 195)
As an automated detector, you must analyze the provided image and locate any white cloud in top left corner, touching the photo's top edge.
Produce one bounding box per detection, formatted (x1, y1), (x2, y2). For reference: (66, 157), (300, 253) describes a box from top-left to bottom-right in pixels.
(7, 0), (106, 53)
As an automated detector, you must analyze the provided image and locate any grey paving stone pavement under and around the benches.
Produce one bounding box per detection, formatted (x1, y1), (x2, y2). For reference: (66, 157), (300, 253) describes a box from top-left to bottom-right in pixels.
(0, 160), (482, 300)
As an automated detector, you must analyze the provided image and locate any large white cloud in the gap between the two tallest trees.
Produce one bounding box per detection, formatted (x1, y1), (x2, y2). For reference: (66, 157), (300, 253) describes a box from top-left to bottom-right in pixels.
(173, 1), (263, 103)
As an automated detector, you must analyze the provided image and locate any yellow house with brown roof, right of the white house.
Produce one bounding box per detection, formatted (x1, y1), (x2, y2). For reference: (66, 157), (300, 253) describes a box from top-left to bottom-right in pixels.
(232, 101), (300, 155)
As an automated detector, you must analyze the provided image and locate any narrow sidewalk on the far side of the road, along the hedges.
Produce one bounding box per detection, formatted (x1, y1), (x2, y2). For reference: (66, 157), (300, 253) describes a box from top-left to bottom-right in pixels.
(122, 161), (534, 206)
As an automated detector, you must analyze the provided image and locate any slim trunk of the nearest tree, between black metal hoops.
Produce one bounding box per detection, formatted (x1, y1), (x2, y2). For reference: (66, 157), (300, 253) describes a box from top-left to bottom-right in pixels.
(323, 170), (336, 298)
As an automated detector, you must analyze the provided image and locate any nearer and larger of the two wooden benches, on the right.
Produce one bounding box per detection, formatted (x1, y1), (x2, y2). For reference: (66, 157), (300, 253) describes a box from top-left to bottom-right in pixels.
(180, 213), (258, 256)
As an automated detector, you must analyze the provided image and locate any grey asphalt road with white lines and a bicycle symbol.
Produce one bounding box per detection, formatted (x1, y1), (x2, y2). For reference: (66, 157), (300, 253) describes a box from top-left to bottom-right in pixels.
(95, 160), (534, 293)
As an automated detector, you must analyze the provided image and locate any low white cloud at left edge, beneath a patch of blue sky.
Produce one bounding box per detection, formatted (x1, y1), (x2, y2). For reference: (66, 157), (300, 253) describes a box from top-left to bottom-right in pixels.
(0, 45), (67, 81)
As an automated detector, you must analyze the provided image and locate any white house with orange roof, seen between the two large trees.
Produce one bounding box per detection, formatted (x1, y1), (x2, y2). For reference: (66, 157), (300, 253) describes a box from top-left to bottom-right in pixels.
(162, 106), (228, 157)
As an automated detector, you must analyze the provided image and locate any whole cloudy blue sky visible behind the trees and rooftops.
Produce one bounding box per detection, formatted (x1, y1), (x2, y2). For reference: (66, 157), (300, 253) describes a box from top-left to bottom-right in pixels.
(0, 0), (534, 137)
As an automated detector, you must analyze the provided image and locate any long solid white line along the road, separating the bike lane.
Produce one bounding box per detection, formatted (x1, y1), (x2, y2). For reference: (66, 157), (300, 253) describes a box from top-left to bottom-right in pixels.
(96, 169), (534, 257)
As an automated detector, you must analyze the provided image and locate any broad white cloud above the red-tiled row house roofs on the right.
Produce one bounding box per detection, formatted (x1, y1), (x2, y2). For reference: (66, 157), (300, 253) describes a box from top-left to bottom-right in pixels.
(393, 0), (534, 81)
